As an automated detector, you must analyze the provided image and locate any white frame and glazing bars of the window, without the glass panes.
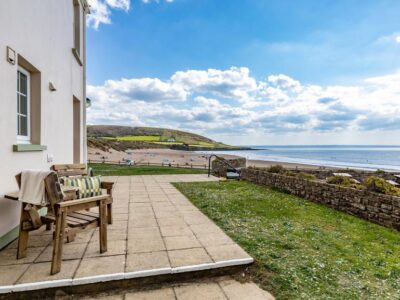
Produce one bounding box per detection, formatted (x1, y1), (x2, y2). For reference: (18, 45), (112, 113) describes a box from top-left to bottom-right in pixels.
(17, 66), (31, 144)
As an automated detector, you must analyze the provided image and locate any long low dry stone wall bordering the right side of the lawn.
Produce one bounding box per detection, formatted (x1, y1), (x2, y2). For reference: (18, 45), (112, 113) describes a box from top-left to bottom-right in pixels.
(242, 168), (400, 230)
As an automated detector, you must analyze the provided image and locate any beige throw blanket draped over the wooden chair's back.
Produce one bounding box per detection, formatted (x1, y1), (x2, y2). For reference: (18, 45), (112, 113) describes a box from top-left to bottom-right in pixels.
(19, 170), (51, 206)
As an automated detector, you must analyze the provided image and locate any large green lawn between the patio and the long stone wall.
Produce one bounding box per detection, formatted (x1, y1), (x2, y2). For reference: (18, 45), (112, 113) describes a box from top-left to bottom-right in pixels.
(175, 181), (400, 299)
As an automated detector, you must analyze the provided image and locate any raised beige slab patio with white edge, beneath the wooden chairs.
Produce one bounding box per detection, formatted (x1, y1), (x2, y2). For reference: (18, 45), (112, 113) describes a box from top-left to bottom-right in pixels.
(0, 174), (253, 293)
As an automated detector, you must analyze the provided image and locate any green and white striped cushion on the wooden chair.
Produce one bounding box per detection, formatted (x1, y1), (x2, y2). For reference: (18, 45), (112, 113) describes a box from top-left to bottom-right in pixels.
(62, 176), (102, 199)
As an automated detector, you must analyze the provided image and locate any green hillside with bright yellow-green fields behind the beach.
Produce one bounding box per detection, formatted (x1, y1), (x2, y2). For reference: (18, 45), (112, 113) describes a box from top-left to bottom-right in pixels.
(87, 125), (244, 151)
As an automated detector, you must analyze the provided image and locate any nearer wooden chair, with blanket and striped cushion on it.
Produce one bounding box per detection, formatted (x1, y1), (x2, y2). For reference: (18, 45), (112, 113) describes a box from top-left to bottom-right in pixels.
(13, 172), (110, 275)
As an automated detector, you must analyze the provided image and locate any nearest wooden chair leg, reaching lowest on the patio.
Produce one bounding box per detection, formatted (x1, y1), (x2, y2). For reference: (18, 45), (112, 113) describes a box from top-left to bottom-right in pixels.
(50, 210), (67, 275)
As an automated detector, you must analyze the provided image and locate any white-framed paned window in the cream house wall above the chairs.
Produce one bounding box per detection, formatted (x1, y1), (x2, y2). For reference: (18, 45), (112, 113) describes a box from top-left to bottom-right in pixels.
(17, 67), (31, 143)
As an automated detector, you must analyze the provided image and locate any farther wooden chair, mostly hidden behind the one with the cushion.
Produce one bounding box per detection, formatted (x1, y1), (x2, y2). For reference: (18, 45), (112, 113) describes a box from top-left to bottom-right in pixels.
(51, 164), (114, 224)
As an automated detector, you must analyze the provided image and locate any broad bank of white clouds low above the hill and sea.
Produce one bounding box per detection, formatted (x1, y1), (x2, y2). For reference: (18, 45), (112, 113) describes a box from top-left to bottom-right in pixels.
(88, 67), (400, 135)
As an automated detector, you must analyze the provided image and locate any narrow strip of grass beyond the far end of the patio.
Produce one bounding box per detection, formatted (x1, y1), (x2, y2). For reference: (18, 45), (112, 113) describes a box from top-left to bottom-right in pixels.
(89, 164), (207, 176)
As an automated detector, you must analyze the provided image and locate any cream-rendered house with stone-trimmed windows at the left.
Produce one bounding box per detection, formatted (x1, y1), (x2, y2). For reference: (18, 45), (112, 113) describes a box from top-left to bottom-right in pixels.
(0, 0), (88, 249)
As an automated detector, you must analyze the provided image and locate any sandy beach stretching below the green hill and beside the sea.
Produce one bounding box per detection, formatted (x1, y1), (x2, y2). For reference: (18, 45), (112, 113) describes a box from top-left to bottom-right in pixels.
(88, 148), (332, 170)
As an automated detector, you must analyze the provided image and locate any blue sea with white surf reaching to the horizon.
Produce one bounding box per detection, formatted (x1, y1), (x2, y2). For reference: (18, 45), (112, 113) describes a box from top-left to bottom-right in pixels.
(203, 145), (400, 171)
